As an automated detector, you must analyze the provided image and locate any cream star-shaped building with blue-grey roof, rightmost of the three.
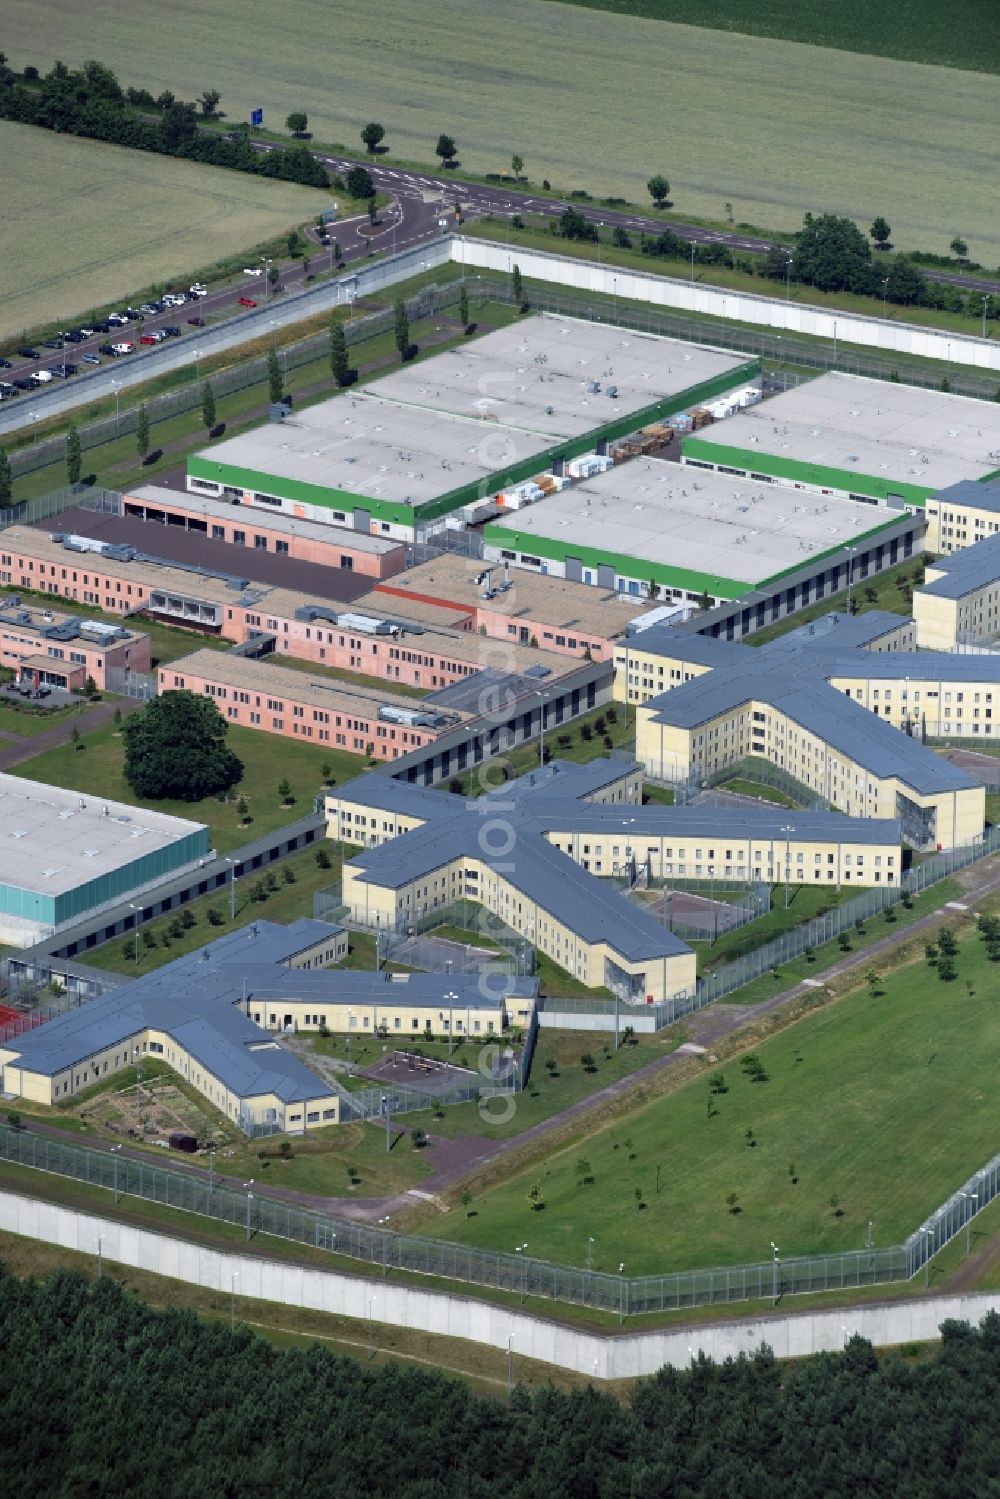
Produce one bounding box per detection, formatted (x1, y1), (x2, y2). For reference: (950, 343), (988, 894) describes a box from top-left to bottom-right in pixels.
(628, 627), (1000, 848)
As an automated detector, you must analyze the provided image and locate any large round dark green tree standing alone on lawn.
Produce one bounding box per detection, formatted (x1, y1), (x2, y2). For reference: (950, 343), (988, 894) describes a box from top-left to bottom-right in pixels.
(121, 693), (243, 802)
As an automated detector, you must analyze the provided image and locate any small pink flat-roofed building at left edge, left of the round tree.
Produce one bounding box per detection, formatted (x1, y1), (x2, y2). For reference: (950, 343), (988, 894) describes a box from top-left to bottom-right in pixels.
(0, 593), (151, 693)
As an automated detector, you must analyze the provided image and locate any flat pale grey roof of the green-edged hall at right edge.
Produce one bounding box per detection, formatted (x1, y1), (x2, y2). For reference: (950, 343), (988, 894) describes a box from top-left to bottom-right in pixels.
(697, 375), (1000, 489)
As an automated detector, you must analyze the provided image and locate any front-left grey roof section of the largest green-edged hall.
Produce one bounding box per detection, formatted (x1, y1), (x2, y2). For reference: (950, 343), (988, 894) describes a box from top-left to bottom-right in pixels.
(191, 395), (552, 507)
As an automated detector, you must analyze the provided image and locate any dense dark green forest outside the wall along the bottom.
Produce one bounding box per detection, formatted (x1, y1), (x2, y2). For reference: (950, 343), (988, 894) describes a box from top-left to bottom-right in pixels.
(0, 1270), (1000, 1499)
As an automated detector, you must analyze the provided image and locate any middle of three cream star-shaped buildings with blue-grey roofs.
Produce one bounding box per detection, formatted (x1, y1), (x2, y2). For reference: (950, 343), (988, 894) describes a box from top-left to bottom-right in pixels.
(325, 760), (903, 1003)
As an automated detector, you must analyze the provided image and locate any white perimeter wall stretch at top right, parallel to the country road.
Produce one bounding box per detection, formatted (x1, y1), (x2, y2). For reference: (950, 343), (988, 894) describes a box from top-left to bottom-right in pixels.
(451, 235), (1000, 370)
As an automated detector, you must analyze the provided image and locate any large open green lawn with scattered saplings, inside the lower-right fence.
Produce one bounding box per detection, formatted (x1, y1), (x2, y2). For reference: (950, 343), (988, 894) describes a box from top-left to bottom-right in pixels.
(422, 905), (1000, 1274)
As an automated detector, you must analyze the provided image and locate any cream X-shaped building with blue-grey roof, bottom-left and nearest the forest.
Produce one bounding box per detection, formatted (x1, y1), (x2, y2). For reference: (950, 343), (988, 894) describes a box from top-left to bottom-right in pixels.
(0, 919), (538, 1135)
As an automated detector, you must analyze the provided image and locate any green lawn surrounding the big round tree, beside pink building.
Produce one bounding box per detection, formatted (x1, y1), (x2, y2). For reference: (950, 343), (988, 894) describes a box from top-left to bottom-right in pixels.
(18, 724), (371, 853)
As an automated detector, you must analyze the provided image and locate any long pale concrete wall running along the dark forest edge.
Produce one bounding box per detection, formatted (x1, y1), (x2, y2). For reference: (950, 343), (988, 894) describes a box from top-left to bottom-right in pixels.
(0, 1192), (1000, 1379)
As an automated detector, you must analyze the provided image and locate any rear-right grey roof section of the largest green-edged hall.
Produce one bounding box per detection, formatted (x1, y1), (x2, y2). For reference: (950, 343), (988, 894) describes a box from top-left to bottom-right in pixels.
(364, 313), (747, 439)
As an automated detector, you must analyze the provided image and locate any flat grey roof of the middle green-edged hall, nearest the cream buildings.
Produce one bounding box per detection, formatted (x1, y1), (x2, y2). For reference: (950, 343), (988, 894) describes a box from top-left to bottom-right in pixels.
(486, 458), (895, 589)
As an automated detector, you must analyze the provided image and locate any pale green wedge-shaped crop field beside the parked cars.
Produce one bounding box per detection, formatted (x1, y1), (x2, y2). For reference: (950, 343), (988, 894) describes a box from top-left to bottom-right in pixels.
(0, 120), (322, 337)
